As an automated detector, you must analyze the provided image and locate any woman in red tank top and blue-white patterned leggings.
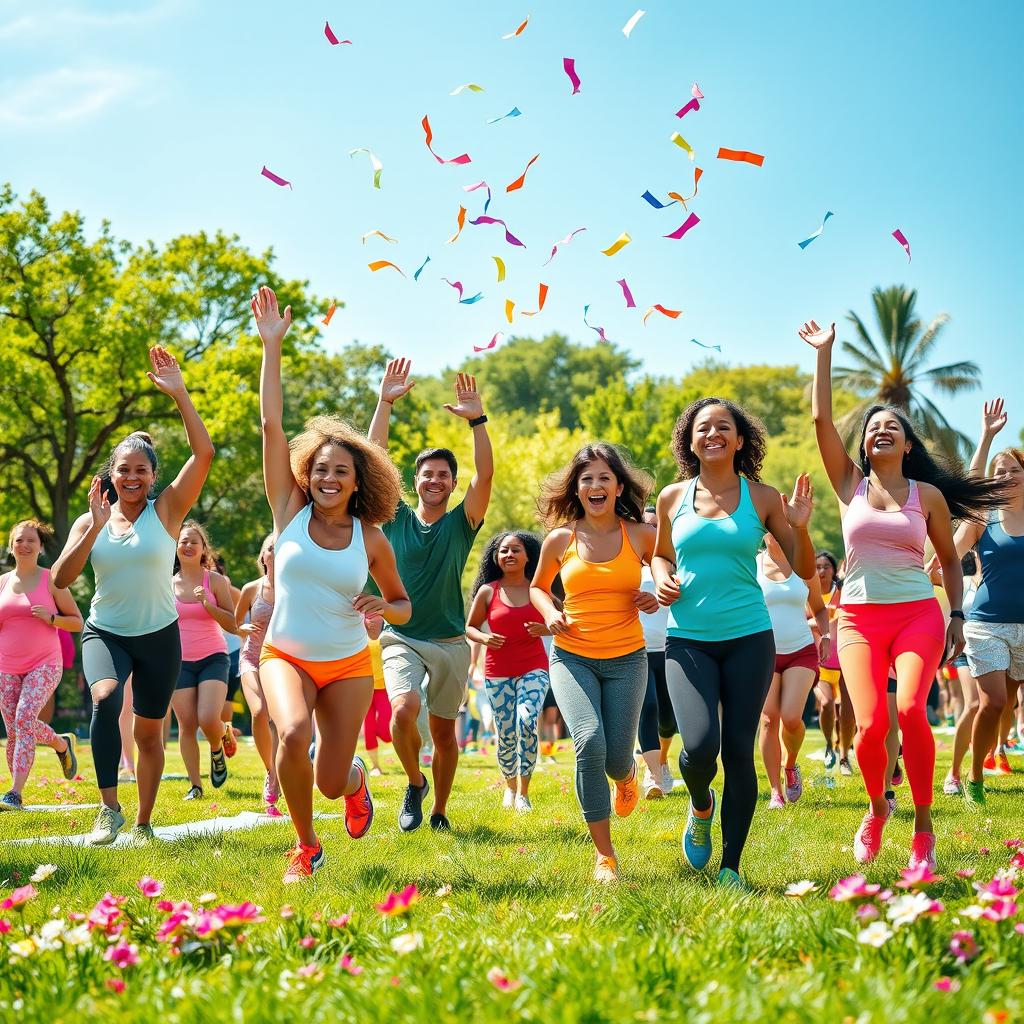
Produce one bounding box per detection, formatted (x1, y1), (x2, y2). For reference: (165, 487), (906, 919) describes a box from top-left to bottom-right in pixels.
(466, 530), (550, 812)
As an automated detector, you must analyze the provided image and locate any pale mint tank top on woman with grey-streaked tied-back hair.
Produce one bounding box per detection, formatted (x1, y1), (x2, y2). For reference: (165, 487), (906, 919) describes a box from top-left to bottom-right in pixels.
(89, 501), (178, 637)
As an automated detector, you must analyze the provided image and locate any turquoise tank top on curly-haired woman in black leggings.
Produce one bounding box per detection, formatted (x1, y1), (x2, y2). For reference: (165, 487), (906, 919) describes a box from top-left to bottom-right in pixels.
(669, 476), (771, 640)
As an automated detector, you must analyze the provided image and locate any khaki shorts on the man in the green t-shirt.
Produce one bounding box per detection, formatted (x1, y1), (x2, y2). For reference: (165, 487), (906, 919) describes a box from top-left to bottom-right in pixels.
(381, 630), (470, 721)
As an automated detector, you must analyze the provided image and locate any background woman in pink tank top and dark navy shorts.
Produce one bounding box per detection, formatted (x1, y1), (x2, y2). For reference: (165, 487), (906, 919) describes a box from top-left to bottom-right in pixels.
(171, 519), (236, 800)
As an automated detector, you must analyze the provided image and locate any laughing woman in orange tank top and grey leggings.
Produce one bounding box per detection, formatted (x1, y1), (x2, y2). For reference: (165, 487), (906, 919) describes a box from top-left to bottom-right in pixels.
(529, 441), (657, 882)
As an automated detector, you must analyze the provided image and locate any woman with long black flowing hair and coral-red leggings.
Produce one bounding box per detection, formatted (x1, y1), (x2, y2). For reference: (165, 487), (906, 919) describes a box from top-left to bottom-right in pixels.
(799, 321), (1006, 869)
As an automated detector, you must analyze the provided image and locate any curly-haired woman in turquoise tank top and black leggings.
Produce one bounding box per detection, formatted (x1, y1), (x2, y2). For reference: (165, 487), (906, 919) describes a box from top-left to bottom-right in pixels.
(652, 398), (814, 889)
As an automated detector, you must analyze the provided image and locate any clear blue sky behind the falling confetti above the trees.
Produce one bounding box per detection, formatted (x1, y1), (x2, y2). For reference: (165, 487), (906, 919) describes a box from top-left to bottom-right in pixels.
(0, 0), (1024, 439)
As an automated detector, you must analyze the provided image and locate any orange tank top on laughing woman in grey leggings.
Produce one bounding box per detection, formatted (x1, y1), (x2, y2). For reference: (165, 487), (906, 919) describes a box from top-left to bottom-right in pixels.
(554, 520), (643, 658)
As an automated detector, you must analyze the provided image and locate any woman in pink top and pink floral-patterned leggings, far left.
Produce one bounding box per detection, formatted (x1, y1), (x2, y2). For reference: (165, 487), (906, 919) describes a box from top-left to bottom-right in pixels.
(0, 519), (82, 811)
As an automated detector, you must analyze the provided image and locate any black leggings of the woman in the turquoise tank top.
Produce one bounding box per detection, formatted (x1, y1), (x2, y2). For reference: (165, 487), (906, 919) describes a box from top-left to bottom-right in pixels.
(666, 630), (775, 871)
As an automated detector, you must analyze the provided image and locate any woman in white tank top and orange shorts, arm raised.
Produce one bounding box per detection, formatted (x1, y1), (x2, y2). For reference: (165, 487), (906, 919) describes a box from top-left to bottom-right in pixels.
(252, 287), (412, 883)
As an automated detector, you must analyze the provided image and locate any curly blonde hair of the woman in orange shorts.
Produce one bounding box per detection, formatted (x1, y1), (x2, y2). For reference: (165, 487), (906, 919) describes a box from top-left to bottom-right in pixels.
(288, 416), (401, 526)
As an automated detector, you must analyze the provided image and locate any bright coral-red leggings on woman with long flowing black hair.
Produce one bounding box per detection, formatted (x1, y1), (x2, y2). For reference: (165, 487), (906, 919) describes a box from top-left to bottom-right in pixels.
(839, 598), (945, 807)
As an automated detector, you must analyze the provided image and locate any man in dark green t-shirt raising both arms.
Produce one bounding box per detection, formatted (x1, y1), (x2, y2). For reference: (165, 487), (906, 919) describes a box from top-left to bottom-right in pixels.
(370, 358), (494, 831)
